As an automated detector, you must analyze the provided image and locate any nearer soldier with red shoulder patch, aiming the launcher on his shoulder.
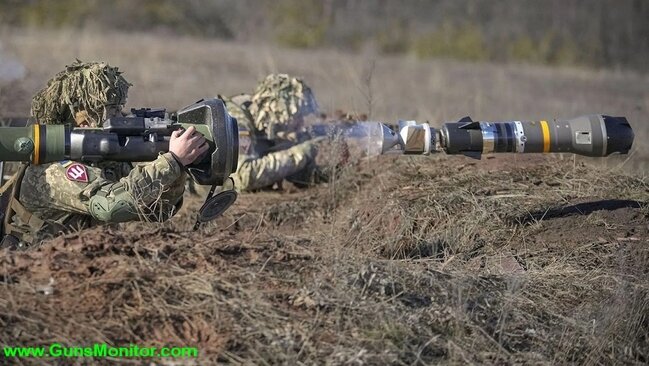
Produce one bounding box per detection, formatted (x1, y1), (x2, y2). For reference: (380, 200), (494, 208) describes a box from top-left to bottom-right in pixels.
(1, 61), (209, 246)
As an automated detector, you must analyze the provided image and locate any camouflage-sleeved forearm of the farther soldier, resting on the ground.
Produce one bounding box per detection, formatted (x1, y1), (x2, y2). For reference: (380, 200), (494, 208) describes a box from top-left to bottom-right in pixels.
(232, 141), (316, 191)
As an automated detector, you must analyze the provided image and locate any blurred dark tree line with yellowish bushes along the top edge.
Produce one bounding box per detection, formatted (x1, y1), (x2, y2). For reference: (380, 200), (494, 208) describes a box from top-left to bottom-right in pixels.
(0, 0), (649, 72)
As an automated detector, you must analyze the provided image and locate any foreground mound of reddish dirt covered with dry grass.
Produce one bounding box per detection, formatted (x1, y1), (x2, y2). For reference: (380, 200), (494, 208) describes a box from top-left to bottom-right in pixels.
(0, 156), (649, 365)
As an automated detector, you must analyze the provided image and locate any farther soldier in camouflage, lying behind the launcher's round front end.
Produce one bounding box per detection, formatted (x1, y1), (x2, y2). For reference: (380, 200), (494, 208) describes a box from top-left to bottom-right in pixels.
(220, 74), (317, 191)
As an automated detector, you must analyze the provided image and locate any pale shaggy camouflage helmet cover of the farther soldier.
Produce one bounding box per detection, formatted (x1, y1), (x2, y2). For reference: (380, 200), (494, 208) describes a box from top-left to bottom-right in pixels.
(250, 74), (318, 139)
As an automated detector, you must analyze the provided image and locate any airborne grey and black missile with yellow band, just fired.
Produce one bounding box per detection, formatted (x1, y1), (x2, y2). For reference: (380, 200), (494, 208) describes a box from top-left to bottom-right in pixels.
(384, 115), (634, 158)
